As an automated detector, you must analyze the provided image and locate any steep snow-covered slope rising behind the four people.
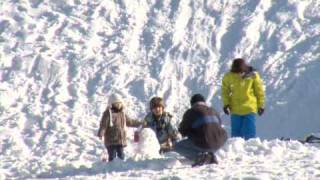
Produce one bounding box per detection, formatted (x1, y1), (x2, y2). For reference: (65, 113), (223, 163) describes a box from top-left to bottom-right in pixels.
(0, 0), (320, 179)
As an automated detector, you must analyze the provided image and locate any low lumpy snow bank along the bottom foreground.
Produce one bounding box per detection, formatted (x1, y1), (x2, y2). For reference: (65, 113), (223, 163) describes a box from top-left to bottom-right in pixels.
(40, 138), (320, 179)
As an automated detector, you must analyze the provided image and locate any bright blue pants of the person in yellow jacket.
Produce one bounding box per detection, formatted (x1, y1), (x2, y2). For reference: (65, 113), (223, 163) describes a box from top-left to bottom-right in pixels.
(231, 113), (256, 140)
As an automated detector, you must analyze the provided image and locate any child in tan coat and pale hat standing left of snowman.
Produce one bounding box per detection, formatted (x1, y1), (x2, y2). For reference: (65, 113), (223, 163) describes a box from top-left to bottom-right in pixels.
(98, 94), (142, 161)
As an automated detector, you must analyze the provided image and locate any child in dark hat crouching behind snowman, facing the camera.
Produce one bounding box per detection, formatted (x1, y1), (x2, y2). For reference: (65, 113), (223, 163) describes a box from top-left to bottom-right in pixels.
(144, 97), (178, 153)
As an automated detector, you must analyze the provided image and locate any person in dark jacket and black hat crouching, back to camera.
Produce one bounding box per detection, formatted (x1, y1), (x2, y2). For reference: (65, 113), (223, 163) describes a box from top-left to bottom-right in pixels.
(175, 94), (227, 166)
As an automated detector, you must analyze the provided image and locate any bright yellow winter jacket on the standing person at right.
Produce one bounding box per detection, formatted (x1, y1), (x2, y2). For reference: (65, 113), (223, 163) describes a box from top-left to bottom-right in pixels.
(222, 72), (265, 115)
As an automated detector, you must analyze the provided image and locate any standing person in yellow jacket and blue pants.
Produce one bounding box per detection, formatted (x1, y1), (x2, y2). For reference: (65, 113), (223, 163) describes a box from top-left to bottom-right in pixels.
(222, 58), (265, 140)
